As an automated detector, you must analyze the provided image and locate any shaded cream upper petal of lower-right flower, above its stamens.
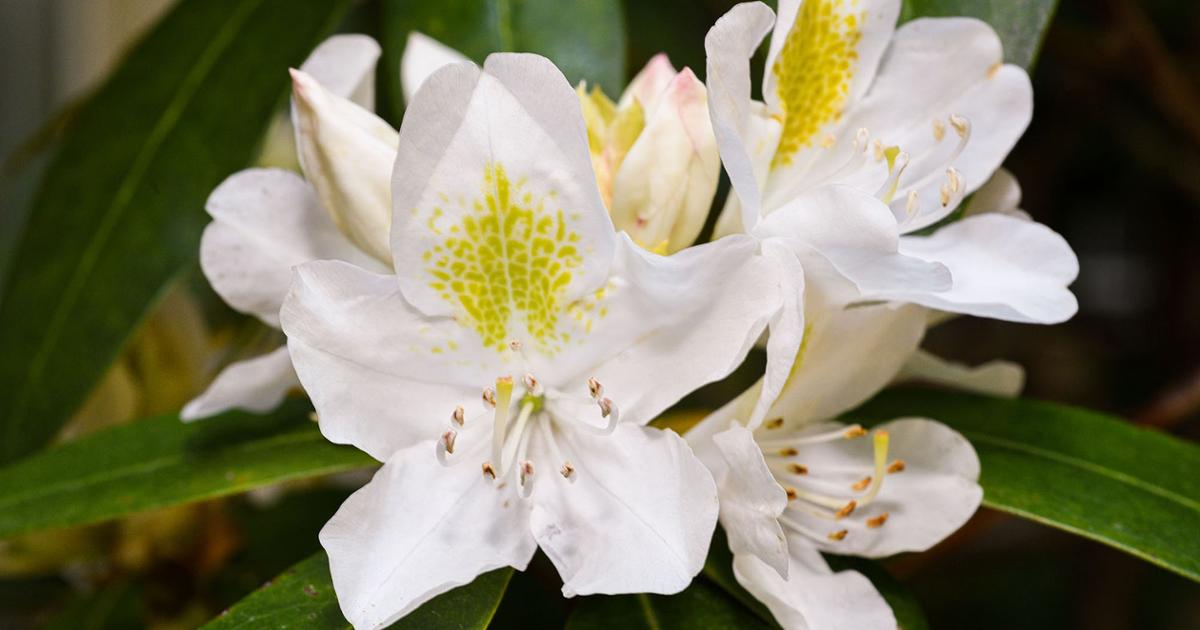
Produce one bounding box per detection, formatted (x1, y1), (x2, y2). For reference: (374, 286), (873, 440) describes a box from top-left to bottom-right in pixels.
(768, 304), (925, 426)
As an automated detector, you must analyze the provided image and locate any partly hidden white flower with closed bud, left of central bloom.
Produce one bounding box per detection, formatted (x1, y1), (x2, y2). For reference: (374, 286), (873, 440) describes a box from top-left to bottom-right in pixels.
(181, 35), (396, 420)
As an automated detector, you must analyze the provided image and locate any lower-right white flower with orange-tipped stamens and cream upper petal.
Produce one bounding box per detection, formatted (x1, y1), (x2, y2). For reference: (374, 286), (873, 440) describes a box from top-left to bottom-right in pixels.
(688, 272), (982, 630)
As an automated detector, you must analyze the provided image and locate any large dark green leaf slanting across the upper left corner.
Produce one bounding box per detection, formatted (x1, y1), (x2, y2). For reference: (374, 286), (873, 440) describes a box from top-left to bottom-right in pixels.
(0, 0), (348, 462)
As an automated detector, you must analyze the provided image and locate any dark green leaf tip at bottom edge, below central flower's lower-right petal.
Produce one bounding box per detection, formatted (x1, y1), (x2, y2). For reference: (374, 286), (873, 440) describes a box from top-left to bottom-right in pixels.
(566, 578), (772, 630)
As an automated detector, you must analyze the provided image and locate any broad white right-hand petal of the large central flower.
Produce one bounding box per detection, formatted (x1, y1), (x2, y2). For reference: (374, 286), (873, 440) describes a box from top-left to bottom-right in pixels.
(553, 236), (779, 424)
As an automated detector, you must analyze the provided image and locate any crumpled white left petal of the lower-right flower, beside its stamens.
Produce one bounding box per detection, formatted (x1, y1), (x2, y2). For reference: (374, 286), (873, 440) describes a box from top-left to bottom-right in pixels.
(713, 425), (788, 578)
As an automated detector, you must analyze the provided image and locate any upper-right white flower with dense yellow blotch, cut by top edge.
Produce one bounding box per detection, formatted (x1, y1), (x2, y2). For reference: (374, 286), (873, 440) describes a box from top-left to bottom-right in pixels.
(706, 0), (1079, 426)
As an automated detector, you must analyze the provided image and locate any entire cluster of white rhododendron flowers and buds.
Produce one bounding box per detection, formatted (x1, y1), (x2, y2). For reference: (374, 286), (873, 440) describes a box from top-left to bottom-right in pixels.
(186, 0), (1078, 628)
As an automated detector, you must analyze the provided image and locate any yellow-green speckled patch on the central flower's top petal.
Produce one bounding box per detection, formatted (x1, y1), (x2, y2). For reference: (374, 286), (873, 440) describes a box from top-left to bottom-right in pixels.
(424, 164), (583, 354)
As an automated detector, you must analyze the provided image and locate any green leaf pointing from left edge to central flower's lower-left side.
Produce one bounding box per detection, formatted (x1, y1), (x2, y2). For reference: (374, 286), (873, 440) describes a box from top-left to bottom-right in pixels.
(0, 401), (376, 539)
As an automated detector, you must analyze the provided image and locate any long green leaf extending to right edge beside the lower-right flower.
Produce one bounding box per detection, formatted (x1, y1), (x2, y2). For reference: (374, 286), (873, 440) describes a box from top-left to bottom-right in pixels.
(848, 389), (1200, 581)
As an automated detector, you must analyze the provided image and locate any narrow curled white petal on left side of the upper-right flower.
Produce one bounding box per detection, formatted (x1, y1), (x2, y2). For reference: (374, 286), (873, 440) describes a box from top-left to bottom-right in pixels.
(704, 2), (778, 229)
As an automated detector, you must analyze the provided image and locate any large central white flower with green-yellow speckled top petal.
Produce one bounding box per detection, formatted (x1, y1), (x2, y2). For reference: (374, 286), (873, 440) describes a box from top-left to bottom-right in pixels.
(281, 54), (778, 628)
